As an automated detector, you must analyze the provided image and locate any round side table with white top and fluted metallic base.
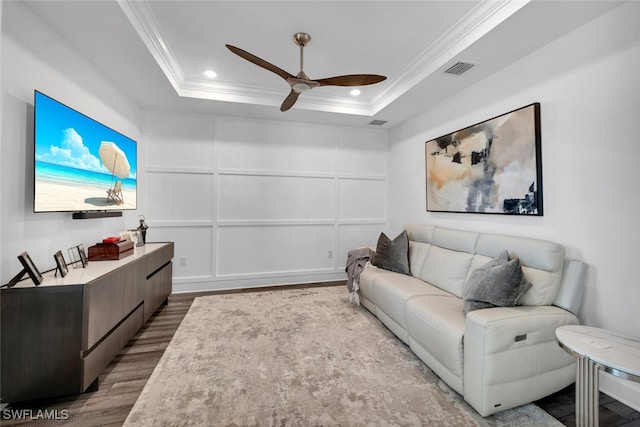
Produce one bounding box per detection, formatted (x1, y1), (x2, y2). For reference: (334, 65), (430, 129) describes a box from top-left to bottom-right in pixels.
(556, 325), (640, 427)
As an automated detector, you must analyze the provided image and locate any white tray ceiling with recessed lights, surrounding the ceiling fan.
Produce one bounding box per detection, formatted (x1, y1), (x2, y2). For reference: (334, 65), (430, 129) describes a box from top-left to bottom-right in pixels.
(20, 0), (622, 125)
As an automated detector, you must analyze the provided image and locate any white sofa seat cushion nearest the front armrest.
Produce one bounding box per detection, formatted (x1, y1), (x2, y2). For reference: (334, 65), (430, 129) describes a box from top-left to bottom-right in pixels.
(406, 295), (465, 380)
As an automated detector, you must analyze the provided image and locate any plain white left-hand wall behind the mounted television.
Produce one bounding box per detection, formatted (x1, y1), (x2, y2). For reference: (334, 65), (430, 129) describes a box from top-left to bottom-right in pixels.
(0, 2), (140, 283)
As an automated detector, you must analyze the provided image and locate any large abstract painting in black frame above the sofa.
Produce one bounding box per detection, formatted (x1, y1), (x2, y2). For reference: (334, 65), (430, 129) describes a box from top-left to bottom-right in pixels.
(425, 103), (543, 216)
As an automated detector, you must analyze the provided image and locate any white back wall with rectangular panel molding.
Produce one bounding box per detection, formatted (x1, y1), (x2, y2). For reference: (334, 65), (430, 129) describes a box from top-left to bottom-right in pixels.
(142, 111), (388, 292)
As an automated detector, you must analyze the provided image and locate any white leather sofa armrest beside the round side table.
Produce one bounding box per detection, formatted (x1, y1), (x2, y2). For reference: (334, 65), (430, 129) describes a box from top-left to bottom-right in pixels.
(463, 306), (578, 416)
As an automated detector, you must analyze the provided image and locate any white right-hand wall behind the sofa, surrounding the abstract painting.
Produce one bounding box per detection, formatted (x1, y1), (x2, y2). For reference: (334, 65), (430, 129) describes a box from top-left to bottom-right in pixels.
(389, 2), (640, 407)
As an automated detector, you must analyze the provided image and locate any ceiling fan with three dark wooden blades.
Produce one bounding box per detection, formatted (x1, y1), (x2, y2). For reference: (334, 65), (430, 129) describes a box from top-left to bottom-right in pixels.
(225, 33), (386, 111)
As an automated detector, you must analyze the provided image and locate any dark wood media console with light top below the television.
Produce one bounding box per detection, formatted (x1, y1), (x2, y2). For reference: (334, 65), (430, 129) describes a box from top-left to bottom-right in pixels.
(0, 242), (173, 403)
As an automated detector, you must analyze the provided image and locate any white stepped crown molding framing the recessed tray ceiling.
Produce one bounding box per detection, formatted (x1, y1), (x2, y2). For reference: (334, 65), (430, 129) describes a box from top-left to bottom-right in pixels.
(117, 0), (531, 116)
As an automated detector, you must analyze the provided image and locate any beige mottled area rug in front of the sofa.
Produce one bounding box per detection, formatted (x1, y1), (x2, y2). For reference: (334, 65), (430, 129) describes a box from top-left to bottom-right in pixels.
(125, 287), (561, 426)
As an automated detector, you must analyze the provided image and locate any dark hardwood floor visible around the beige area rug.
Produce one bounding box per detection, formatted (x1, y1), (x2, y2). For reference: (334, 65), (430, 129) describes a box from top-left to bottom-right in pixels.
(0, 282), (640, 427)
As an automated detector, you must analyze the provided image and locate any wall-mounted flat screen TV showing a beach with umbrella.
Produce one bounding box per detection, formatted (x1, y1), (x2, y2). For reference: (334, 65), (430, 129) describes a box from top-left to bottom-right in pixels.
(33, 90), (137, 216)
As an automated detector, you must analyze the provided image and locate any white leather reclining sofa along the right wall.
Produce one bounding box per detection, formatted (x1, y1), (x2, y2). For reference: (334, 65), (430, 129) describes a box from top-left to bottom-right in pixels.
(359, 225), (587, 416)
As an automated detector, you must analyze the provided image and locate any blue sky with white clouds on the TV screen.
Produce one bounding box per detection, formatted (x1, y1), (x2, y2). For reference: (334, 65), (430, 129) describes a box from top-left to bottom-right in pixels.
(34, 91), (137, 180)
